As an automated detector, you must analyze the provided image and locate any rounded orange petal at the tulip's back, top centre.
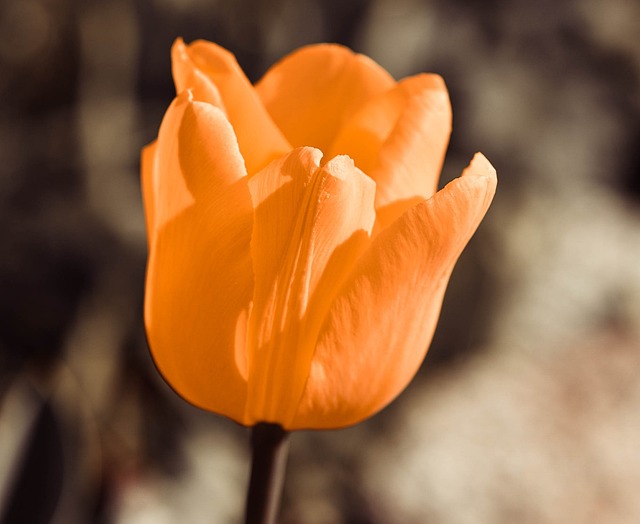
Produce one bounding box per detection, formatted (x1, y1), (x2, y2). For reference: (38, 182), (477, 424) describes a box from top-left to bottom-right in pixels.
(256, 44), (395, 154)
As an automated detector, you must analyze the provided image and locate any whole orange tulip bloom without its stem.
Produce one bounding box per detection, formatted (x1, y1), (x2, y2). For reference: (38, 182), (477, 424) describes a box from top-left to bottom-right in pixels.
(142, 40), (496, 430)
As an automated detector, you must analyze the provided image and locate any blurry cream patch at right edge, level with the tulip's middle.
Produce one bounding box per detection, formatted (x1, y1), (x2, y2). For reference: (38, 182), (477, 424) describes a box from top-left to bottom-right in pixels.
(492, 187), (640, 355)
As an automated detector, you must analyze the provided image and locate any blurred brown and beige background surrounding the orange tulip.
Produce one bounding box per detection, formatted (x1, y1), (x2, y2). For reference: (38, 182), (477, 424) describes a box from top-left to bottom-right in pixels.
(0, 0), (640, 524)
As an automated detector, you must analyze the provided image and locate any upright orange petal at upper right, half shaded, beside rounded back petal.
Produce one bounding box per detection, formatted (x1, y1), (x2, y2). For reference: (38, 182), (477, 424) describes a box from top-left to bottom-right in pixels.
(329, 74), (451, 227)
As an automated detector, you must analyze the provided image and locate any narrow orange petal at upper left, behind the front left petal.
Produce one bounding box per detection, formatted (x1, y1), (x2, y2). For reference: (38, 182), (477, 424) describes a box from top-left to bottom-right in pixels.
(171, 39), (291, 175)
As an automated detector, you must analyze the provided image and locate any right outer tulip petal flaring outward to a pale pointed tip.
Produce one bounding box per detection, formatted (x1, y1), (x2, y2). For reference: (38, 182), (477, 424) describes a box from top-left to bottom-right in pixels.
(290, 155), (496, 429)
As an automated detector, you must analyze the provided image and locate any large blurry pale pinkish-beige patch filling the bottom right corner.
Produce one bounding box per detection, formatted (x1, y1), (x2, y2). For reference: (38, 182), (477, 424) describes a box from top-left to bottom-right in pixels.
(363, 335), (640, 524)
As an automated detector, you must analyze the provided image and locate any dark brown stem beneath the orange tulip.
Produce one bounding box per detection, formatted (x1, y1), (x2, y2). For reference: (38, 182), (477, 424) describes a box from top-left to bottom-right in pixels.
(245, 422), (289, 524)
